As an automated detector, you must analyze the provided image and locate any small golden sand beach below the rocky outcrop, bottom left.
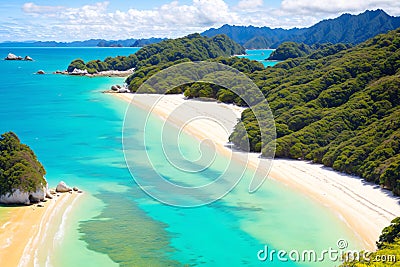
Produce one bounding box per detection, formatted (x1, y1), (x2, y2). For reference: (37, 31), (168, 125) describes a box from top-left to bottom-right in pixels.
(0, 193), (81, 267)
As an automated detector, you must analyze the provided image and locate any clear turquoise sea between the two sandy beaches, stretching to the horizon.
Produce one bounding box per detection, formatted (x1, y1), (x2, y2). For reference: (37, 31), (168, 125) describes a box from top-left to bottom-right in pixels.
(0, 48), (360, 267)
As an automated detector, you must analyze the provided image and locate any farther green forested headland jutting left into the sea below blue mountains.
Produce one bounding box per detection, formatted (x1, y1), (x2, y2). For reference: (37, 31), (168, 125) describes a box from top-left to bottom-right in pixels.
(67, 33), (245, 73)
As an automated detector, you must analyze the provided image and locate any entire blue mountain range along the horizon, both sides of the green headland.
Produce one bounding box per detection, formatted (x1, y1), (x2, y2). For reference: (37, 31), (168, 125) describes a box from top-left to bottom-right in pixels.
(0, 9), (400, 49)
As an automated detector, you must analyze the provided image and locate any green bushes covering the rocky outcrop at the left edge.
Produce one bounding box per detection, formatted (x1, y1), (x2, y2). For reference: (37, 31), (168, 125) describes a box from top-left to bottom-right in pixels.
(0, 132), (46, 195)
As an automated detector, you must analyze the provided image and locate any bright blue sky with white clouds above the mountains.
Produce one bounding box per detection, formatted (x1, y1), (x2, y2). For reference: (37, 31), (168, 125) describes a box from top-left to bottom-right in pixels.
(0, 0), (400, 42)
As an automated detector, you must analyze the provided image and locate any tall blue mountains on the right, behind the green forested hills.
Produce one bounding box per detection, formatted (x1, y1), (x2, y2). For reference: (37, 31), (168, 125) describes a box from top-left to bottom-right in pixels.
(202, 9), (400, 49)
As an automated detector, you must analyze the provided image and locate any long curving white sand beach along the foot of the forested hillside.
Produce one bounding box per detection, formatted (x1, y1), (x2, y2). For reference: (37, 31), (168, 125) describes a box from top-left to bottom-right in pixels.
(113, 94), (400, 250)
